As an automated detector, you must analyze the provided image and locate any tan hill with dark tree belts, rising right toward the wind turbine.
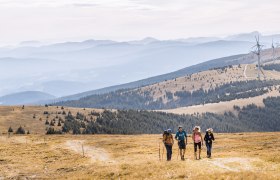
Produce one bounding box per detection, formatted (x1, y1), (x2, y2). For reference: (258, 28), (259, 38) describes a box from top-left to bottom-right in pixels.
(56, 56), (280, 112)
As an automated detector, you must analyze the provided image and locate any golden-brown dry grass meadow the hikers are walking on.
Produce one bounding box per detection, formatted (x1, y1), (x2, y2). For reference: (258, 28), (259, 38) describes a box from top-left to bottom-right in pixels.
(0, 133), (280, 179)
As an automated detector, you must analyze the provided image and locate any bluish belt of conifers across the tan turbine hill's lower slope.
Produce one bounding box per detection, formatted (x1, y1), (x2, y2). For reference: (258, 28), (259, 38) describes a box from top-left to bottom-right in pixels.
(56, 80), (280, 110)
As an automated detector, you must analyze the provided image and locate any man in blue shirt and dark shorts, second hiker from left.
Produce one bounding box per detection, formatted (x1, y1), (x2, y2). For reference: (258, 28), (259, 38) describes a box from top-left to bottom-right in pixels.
(175, 126), (188, 161)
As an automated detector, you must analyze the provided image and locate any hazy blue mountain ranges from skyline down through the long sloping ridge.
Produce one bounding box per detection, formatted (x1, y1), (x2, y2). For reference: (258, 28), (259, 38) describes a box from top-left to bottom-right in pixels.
(0, 32), (280, 105)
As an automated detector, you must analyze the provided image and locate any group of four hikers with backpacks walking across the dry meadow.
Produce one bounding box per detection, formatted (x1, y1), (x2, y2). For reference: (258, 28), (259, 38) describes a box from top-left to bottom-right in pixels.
(163, 126), (215, 161)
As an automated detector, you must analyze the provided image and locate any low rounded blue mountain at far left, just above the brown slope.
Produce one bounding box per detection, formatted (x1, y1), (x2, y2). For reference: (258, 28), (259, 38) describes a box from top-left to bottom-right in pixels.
(0, 91), (55, 105)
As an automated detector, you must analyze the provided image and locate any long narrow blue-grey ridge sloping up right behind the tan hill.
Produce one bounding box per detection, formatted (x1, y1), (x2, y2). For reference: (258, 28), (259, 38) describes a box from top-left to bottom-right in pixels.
(42, 46), (280, 104)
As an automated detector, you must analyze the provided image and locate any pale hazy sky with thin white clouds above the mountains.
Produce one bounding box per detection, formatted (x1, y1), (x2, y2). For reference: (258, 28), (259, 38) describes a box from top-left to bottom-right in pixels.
(0, 0), (280, 45)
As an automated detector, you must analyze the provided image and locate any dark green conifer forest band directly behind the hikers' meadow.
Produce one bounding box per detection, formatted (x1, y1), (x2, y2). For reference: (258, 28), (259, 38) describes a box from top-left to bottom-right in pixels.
(47, 97), (280, 134)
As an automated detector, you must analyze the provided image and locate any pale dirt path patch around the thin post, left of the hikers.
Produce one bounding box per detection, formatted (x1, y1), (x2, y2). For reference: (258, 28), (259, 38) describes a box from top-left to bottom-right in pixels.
(65, 140), (114, 163)
